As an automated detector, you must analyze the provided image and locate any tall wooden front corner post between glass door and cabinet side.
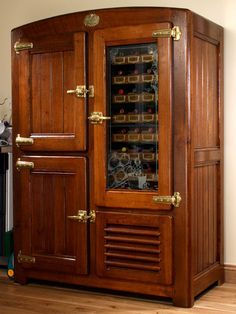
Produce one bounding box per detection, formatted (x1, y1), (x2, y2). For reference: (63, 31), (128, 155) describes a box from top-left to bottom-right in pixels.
(172, 11), (194, 307)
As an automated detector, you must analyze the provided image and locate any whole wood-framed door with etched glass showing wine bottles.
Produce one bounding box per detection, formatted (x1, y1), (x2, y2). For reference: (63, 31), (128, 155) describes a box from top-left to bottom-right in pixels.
(92, 23), (173, 209)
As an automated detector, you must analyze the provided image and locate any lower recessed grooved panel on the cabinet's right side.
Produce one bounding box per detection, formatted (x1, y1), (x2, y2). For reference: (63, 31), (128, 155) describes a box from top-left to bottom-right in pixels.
(193, 164), (219, 274)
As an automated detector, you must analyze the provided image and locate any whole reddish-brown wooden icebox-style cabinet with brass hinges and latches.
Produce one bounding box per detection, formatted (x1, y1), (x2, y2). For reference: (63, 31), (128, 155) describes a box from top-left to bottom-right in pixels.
(12, 8), (224, 307)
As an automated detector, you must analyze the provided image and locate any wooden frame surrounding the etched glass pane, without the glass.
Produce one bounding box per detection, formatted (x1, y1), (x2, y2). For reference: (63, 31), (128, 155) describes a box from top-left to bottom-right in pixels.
(94, 23), (173, 210)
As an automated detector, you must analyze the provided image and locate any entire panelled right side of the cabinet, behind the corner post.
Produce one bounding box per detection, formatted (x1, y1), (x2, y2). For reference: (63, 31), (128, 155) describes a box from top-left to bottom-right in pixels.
(191, 33), (223, 275)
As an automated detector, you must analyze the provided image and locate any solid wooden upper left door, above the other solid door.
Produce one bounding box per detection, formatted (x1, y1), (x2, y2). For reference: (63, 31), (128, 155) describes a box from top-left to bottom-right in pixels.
(15, 33), (87, 151)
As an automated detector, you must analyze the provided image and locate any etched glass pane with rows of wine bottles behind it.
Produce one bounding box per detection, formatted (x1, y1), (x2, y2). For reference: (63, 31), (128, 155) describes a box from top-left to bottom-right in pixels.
(106, 43), (158, 191)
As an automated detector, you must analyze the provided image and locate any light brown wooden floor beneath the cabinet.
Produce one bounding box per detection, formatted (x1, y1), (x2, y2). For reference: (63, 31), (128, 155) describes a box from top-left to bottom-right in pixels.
(0, 278), (236, 314)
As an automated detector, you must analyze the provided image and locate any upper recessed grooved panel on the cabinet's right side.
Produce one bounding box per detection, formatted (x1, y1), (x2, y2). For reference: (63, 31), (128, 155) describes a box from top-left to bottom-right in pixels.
(193, 37), (219, 148)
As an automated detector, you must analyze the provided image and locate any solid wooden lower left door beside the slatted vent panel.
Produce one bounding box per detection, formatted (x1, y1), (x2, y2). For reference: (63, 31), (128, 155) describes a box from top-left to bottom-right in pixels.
(15, 156), (87, 274)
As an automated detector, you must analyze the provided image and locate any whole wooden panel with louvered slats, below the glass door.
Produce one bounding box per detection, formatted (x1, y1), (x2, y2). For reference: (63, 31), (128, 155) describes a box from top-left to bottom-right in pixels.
(96, 211), (172, 285)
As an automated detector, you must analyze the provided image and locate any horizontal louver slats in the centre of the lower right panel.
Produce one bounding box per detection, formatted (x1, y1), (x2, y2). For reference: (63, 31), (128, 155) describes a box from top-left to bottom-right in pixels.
(104, 224), (161, 272)
